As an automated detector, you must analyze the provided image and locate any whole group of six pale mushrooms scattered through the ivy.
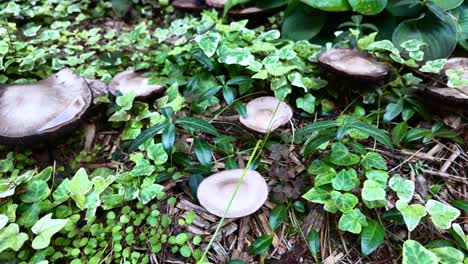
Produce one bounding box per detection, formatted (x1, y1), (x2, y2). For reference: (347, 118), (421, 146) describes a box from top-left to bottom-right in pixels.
(0, 48), (468, 218)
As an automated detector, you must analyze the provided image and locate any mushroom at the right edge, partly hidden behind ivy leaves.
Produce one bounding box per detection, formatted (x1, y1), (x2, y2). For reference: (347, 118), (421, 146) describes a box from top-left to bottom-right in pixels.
(425, 58), (468, 108)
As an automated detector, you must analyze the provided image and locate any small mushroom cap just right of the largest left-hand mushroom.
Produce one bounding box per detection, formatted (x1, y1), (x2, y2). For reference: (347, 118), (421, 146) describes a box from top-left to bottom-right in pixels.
(109, 70), (164, 97)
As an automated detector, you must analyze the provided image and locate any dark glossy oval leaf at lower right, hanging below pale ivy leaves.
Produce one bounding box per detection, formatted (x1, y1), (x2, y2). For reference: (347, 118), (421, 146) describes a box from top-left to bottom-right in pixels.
(361, 220), (385, 256)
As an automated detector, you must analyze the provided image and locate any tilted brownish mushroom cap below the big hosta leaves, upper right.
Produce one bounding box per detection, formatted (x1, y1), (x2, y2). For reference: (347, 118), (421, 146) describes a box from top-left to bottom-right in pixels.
(319, 48), (391, 82)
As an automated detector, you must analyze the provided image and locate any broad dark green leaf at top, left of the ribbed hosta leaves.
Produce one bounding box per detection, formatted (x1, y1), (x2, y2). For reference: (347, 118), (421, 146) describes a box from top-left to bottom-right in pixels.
(281, 1), (326, 40)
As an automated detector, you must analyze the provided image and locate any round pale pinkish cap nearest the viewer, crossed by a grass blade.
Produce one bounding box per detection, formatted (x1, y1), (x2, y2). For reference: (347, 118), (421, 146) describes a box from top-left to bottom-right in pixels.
(197, 169), (268, 218)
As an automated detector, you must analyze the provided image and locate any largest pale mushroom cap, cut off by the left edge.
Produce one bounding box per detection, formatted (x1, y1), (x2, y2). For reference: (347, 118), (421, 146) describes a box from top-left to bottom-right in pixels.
(0, 68), (93, 144)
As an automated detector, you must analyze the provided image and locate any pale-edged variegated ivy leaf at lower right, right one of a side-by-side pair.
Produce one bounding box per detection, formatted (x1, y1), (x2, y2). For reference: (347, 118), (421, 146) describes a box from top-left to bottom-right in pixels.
(426, 199), (461, 229)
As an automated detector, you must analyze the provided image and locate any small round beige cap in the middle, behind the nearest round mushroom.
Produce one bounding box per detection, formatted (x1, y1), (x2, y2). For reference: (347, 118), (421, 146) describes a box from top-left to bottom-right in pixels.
(239, 96), (293, 133)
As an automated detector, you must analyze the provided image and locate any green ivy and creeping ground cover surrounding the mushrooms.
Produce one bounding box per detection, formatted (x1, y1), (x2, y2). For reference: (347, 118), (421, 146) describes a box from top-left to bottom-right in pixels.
(0, 1), (468, 263)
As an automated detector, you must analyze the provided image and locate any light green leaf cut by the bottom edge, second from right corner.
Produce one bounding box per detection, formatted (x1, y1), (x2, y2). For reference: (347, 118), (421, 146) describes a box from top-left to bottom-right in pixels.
(402, 240), (439, 264)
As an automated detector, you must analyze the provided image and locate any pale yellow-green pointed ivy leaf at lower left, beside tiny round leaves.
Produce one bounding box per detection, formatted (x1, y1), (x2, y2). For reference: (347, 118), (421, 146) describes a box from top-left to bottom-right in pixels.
(31, 213), (68, 249)
